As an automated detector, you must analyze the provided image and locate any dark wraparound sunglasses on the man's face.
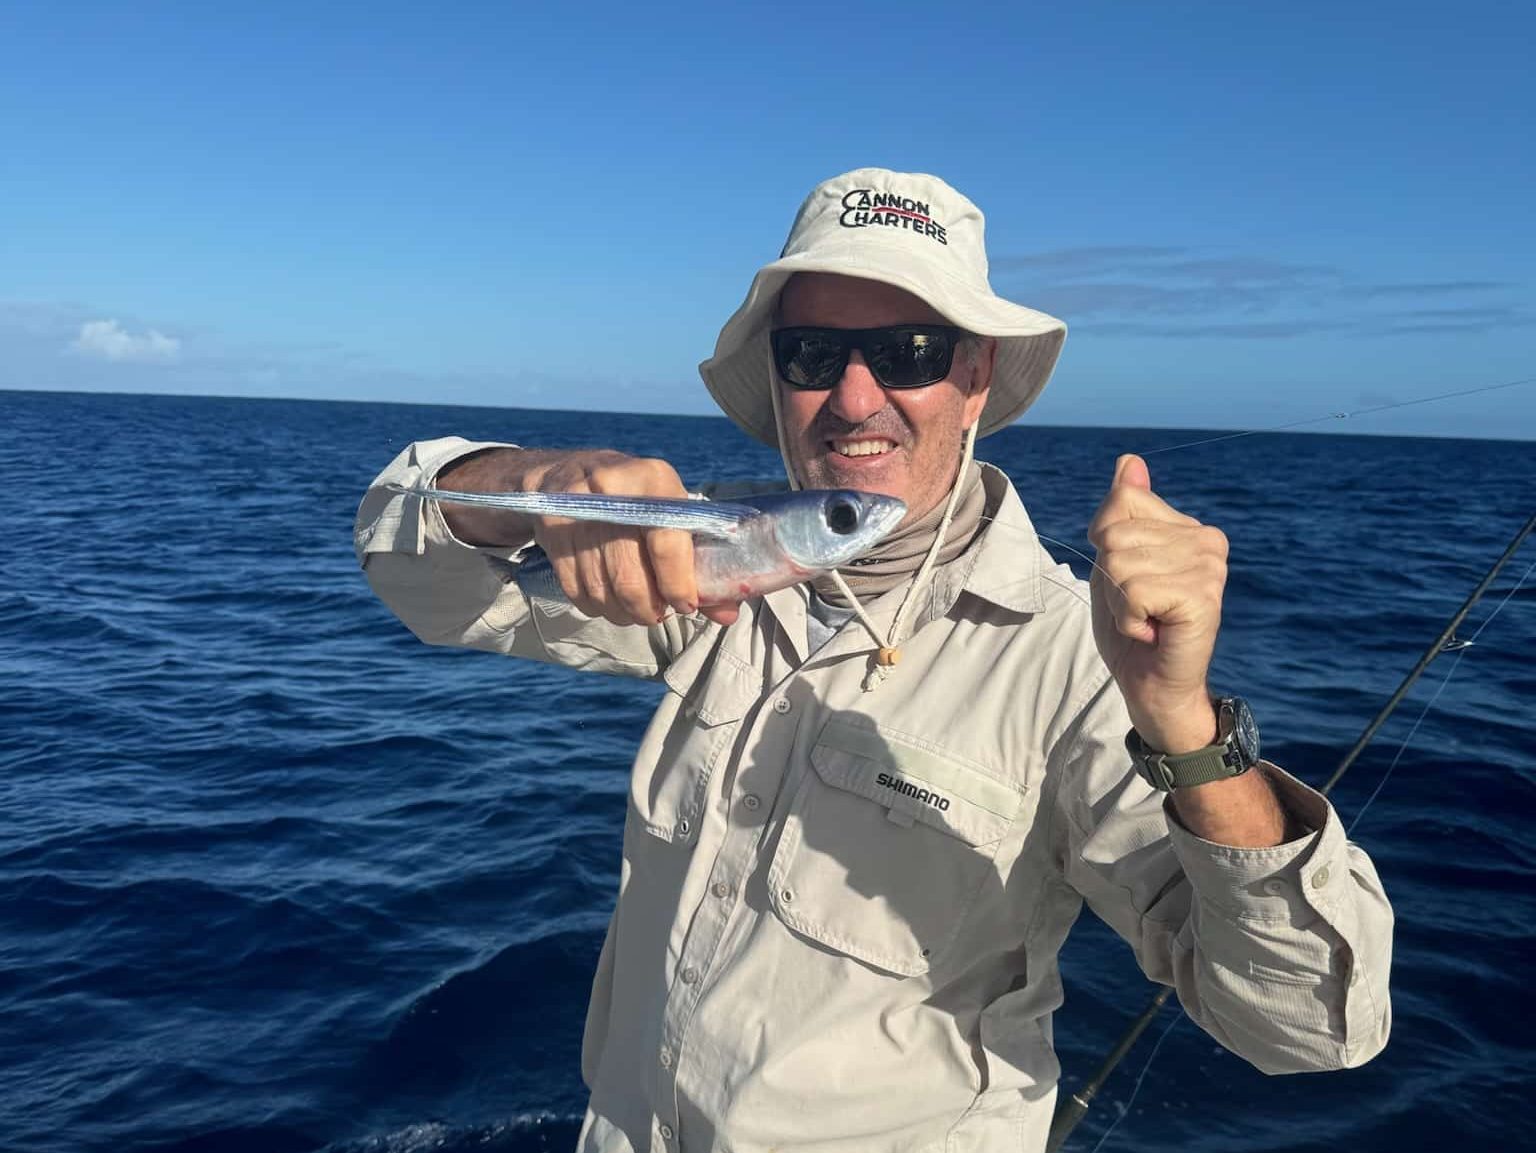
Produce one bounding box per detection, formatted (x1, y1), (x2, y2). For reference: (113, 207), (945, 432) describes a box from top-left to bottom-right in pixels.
(768, 324), (965, 390)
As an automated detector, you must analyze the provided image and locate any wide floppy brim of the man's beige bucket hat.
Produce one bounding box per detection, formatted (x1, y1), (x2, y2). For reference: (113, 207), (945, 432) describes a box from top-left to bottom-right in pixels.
(699, 246), (1066, 445)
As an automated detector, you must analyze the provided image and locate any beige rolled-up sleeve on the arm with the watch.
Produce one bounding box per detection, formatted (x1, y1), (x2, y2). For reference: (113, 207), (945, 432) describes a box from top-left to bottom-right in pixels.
(1057, 682), (1393, 1073)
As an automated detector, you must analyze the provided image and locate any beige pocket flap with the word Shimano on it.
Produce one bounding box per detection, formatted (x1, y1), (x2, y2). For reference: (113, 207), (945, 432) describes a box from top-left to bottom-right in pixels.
(811, 720), (1023, 844)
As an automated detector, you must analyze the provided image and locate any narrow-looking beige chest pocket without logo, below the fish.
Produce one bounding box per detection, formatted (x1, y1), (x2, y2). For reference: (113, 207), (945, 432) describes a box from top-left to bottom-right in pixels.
(630, 632), (762, 844)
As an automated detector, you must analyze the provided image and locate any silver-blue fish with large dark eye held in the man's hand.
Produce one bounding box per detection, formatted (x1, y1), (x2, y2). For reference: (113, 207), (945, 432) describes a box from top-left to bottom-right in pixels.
(396, 487), (906, 605)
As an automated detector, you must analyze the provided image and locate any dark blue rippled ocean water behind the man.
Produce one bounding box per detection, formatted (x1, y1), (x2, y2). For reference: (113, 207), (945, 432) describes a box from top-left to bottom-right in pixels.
(0, 391), (1536, 1153)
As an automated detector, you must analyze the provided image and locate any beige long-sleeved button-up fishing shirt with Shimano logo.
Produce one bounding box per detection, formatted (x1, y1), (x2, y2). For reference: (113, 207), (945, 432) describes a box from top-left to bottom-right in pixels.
(356, 438), (1392, 1153)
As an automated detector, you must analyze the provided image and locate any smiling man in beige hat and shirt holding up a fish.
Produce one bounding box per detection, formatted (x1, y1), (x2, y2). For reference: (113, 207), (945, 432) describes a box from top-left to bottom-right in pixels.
(358, 169), (1392, 1153)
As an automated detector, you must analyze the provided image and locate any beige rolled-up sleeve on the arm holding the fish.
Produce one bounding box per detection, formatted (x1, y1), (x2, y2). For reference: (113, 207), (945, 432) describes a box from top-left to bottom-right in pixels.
(352, 436), (699, 677)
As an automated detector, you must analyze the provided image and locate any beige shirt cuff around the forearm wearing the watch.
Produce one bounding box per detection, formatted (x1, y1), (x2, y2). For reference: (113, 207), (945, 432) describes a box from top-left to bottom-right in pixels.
(1164, 762), (1349, 921)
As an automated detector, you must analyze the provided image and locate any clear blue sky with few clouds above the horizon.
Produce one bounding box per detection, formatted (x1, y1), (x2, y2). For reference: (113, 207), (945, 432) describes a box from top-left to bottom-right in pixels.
(0, 0), (1536, 438)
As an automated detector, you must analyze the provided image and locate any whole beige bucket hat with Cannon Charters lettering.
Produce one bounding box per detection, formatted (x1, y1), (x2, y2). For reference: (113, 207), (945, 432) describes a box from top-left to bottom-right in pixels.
(699, 169), (1066, 445)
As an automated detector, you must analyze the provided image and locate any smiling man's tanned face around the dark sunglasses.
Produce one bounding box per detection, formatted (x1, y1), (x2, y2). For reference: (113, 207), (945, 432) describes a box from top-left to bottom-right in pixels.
(777, 272), (997, 525)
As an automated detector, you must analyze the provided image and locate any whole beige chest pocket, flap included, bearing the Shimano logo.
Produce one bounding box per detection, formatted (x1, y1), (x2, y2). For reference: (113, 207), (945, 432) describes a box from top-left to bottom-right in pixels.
(768, 720), (1025, 976)
